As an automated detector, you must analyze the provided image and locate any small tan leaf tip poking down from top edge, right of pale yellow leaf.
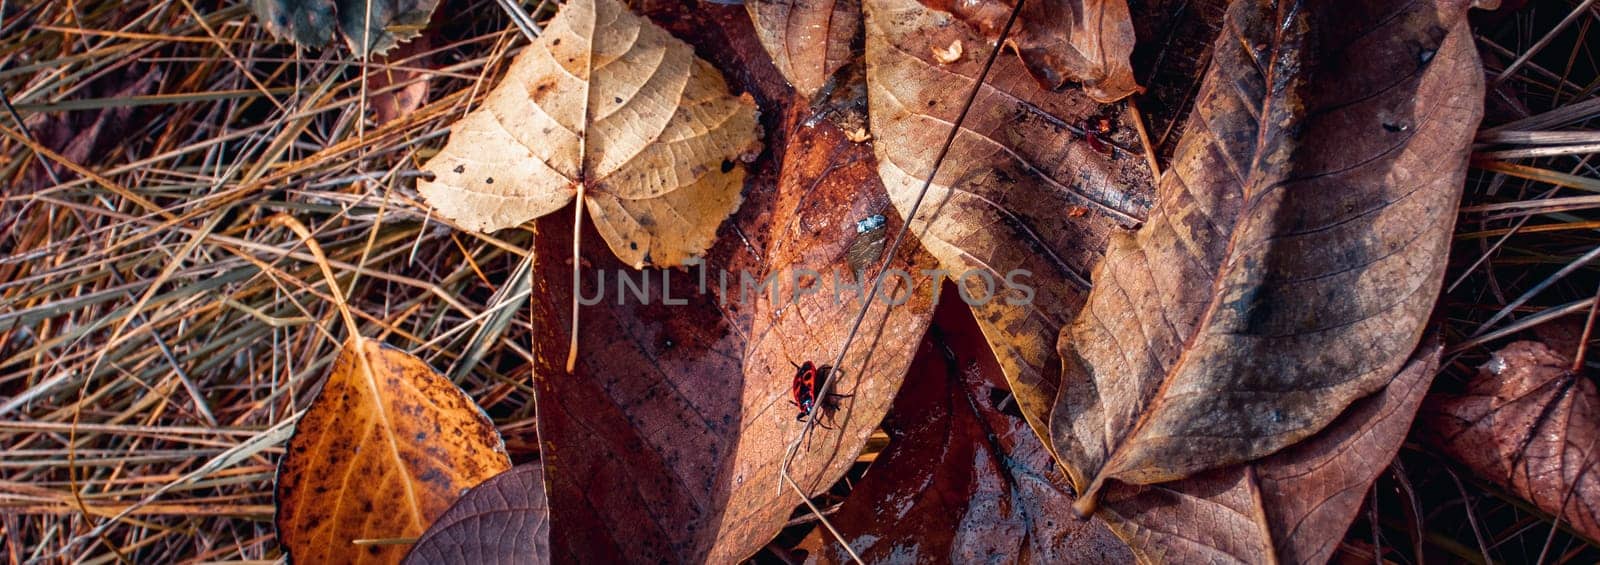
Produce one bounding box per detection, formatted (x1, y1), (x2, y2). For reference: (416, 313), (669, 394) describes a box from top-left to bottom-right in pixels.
(744, 0), (861, 98)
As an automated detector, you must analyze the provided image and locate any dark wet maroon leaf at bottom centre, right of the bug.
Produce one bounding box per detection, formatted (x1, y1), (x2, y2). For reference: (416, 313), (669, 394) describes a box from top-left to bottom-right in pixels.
(813, 297), (1133, 563)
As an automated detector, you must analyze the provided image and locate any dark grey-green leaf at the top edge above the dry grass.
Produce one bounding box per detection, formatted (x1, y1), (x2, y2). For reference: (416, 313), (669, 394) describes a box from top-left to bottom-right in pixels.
(251, 0), (438, 56)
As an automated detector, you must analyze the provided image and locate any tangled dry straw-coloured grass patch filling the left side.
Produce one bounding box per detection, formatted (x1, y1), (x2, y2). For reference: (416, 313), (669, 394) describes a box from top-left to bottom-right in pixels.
(0, 0), (533, 562)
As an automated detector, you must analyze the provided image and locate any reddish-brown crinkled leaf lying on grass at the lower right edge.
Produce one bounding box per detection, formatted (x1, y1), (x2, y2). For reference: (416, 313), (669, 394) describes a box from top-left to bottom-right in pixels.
(1422, 341), (1600, 539)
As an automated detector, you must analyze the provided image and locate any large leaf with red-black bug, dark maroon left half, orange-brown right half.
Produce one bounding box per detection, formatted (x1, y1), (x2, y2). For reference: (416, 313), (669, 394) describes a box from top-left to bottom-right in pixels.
(531, 3), (933, 562)
